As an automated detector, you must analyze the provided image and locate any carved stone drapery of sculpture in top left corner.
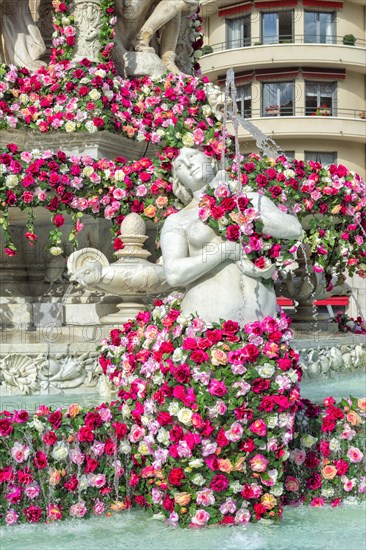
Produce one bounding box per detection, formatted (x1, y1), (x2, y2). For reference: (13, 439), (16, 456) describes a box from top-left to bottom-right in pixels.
(0, 0), (46, 71)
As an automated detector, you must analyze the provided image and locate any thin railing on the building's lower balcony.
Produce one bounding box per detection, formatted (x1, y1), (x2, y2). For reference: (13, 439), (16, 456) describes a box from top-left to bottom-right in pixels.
(234, 106), (366, 120)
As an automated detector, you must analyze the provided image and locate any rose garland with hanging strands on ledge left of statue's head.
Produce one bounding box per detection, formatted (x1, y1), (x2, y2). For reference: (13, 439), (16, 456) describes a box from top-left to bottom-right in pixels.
(0, 144), (176, 256)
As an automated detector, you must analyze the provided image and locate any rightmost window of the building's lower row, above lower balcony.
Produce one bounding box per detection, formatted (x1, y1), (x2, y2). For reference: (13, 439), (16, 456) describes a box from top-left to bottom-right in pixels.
(305, 81), (337, 116)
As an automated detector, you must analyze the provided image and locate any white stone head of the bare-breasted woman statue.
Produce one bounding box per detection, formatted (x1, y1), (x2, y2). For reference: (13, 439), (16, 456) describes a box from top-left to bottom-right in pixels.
(172, 147), (217, 204)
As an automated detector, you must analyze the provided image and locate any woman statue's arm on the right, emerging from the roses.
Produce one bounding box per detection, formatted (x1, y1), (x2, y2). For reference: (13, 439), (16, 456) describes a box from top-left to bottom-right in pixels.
(248, 193), (302, 240)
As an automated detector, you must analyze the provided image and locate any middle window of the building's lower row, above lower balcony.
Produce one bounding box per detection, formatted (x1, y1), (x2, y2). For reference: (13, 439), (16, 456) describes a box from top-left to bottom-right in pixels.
(262, 82), (295, 116)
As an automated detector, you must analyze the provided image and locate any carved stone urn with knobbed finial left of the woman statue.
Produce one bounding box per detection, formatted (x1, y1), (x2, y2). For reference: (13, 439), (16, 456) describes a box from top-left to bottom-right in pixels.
(67, 213), (170, 325)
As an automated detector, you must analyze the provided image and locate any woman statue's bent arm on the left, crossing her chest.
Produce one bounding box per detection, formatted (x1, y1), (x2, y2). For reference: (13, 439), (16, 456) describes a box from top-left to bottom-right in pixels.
(160, 219), (240, 287)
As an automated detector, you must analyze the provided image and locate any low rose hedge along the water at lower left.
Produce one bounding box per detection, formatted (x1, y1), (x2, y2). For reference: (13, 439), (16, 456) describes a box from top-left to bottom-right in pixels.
(0, 404), (131, 525)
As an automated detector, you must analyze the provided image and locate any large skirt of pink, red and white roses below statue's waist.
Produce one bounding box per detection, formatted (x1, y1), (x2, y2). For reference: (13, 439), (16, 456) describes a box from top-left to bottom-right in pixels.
(96, 295), (301, 527)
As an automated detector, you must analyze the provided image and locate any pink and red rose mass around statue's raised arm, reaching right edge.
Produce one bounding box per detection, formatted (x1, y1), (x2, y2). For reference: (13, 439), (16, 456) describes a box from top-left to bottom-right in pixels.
(200, 154), (366, 281)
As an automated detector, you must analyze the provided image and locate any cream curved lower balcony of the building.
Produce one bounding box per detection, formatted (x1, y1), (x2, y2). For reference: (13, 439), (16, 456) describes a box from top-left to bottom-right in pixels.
(229, 107), (366, 143)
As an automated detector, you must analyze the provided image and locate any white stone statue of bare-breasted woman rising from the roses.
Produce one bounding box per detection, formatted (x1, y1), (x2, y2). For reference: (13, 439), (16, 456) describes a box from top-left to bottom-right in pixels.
(161, 147), (302, 323)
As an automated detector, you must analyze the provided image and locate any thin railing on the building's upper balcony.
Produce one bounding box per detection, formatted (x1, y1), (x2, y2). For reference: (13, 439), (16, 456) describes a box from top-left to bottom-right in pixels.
(203, 34), (366, 55)
